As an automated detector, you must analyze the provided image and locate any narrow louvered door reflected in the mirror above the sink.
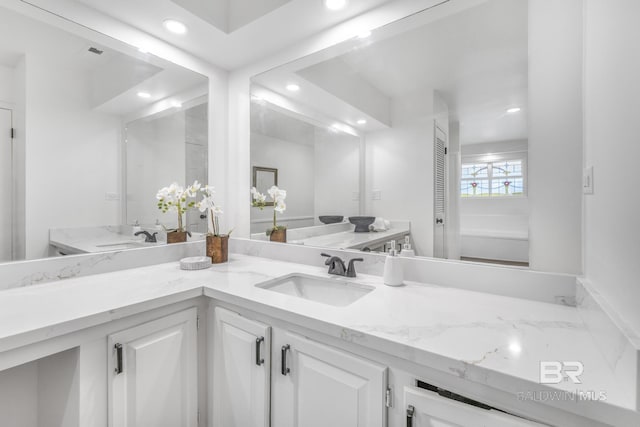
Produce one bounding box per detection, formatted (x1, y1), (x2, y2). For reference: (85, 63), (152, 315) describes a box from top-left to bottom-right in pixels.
(433, 122), (447, 258)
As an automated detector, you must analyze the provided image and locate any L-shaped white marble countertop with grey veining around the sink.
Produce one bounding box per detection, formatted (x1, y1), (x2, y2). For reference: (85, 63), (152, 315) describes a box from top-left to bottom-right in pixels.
(0, 254), (640, 425)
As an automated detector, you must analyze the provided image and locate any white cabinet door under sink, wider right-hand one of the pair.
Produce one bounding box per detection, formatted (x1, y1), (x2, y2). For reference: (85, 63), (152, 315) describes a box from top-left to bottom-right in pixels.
(271, 330), (387, 427)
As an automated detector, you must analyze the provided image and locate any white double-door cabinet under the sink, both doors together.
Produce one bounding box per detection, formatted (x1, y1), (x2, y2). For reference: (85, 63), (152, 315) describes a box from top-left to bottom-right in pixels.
(213, 307), (387, 427)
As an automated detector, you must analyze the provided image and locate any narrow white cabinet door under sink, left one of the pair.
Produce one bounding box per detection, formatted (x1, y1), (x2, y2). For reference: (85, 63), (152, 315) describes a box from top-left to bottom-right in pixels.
(213, 307), (271, 427)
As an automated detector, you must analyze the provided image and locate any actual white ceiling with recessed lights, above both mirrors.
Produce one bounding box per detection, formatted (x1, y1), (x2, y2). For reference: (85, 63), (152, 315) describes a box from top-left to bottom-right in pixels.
(42, 0), (393, 70)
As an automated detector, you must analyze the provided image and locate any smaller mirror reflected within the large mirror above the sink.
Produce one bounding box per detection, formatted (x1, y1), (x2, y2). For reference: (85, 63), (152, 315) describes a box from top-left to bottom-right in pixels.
(251, 99), (360, 241)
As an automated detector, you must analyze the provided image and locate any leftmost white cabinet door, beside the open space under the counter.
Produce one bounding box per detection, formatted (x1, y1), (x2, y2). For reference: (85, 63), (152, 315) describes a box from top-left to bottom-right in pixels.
(107, 308), (198, 427)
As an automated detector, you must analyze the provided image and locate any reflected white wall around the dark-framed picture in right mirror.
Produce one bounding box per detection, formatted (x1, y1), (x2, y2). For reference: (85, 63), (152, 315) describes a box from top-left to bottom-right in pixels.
(245, 132), (315, 233)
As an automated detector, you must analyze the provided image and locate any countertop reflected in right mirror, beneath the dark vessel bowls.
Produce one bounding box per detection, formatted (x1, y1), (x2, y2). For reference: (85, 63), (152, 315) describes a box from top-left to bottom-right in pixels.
(290, 227), (410, 249)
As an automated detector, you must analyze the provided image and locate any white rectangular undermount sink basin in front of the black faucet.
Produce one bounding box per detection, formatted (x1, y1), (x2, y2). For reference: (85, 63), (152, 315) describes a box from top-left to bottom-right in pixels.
(256, 273), (375, 307)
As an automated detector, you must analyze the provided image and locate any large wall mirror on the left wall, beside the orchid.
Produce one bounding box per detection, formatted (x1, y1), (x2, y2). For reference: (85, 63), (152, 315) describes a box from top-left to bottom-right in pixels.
(0, 4), (208, 262)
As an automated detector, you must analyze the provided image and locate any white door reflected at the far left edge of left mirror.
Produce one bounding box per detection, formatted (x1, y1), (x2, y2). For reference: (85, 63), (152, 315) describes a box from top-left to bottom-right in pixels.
(0, 108), (13, 261)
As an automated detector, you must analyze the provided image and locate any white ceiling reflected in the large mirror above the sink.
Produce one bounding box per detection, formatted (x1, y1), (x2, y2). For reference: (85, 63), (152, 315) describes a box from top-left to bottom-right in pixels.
(255, 0), (528, 144)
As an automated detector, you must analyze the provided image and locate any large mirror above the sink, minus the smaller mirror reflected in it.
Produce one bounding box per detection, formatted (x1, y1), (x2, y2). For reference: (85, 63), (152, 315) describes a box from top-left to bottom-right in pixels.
(251, 0), (529, 265)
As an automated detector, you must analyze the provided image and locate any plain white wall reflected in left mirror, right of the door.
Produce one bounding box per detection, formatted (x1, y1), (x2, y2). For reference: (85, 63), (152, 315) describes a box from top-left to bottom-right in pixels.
(24, 50), (121, 259)
